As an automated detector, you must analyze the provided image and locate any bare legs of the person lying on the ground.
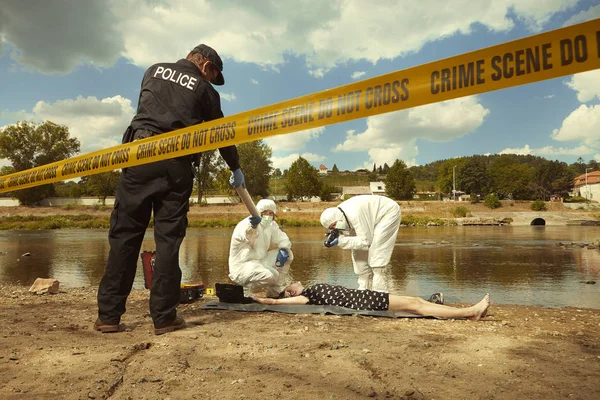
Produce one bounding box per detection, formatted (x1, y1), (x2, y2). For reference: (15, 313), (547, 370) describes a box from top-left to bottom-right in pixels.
(389, 294), (490, 321)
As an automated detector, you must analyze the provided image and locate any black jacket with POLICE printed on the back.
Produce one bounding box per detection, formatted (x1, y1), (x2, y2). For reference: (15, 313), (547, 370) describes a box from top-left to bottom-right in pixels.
(131, 59), (240, 171)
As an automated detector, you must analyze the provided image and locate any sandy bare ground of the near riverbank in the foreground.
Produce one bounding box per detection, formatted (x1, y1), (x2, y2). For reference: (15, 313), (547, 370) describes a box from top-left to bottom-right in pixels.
(0, 286), (600, 400)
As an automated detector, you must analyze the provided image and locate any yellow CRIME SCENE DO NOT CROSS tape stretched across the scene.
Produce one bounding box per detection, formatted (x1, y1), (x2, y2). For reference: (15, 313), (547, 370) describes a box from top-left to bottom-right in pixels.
(0, 19), (600, 193)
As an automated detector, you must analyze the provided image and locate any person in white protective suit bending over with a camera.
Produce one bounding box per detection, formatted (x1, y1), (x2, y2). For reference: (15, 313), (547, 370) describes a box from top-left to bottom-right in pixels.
(321, 195), (400, 292)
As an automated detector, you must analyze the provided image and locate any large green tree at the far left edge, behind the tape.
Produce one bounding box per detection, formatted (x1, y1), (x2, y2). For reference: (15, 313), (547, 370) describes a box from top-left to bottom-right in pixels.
(0, 121), (80, 205)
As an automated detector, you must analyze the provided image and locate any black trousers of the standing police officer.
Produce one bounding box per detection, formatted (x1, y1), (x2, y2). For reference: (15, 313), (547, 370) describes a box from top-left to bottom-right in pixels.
(98, 157), (193, 327)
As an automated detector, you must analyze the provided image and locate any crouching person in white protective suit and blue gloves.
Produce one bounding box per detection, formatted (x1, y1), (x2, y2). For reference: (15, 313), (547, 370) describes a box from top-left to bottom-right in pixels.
(229, 199), (294, 297)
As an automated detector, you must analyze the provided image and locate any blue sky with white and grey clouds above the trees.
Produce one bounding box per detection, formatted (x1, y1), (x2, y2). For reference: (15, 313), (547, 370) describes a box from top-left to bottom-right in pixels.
(0, 0), (600, 170)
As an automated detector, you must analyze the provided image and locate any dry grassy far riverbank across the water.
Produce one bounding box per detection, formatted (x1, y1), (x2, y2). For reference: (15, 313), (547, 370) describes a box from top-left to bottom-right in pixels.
(0, 201), (600, 230)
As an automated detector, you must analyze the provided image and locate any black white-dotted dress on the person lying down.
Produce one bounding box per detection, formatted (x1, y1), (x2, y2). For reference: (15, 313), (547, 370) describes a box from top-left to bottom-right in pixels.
(301, 283), (390, 311)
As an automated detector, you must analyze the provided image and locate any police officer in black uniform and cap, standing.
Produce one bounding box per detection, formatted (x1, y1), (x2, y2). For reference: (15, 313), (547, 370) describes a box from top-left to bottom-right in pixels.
(94, 44), (244, 335)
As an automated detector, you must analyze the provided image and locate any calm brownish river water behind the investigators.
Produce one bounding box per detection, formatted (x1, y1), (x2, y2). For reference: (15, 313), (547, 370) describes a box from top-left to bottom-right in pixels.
(0, 226), (600, 309)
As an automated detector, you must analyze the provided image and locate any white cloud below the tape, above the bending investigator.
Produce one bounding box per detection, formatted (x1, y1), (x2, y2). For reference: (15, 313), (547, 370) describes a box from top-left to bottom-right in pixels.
(334, 96), (490, 165)
